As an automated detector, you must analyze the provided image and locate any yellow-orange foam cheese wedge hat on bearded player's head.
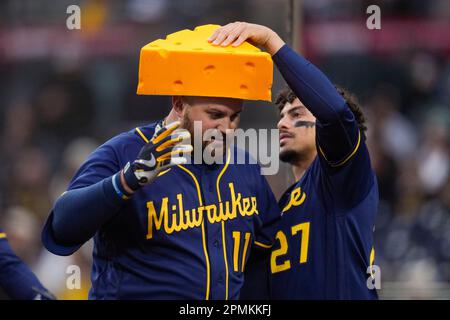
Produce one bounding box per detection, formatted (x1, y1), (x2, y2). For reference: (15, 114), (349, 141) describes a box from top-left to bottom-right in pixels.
(137, 24), (273, 101)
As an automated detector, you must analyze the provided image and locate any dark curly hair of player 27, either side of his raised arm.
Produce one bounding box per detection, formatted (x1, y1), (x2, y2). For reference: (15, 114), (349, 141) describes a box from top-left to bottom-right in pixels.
(275, 85), (367, 139)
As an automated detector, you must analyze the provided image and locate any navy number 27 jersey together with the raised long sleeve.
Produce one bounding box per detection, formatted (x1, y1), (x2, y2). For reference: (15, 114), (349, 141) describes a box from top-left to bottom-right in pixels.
(270, 45), (378, 299)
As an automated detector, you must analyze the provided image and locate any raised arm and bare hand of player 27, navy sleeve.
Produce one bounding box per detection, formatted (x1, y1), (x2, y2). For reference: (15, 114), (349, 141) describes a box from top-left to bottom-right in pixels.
(209, 22), (360, 166)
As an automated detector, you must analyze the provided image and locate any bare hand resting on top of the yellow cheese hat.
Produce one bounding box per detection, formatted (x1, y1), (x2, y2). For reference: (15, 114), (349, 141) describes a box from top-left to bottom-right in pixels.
(208, 22), (284, 55)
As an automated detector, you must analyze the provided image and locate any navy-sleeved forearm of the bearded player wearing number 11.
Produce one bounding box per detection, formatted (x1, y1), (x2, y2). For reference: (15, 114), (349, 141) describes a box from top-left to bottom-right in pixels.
(52, 177), (124, 245)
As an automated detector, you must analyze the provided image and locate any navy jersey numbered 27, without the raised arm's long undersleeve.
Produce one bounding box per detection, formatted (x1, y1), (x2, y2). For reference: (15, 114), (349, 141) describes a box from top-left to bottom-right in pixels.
(270, 138), (378, 299)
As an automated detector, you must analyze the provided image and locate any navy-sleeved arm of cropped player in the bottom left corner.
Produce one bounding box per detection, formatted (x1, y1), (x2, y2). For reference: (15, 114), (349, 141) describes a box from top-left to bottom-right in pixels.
(0, 229), (55, 300)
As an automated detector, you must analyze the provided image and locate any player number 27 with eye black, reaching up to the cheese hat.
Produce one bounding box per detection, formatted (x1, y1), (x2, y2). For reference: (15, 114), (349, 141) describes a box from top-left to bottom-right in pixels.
(209, 22), (378, 299)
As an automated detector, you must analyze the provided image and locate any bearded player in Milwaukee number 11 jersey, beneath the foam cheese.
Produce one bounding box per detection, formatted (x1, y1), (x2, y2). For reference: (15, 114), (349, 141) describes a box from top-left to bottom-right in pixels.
(42, 92), (280, 299)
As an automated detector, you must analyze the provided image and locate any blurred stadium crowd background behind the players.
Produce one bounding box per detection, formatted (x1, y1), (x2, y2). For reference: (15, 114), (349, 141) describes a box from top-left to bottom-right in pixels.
(0, 0), (450, 299)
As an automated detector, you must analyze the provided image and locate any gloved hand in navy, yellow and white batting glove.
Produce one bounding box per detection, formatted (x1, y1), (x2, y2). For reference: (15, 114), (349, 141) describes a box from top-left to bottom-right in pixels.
(123, 121), (192, 191)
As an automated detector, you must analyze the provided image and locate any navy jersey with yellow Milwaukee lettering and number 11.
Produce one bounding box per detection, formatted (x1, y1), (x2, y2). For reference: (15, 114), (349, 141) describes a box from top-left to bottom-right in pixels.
(43, 123), (280, 299)
